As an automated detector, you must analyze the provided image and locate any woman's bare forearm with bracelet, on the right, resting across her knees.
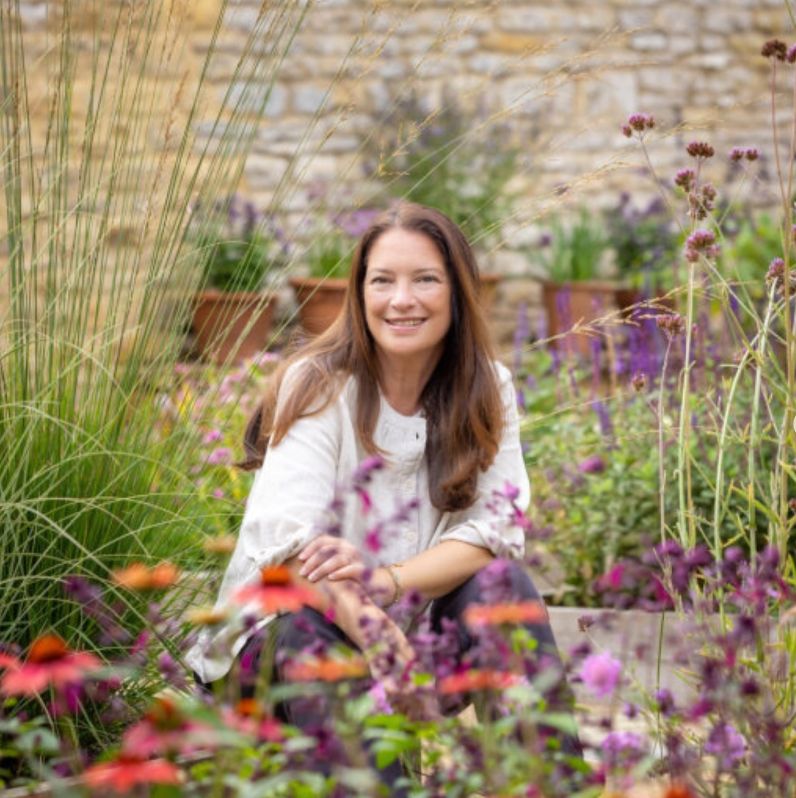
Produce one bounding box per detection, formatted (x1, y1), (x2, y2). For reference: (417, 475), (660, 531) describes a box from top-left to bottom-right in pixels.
(376, 540), (494, 599)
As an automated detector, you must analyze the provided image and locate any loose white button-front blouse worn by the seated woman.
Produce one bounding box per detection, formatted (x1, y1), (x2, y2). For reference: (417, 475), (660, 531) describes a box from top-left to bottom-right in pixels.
(186, 362), (530, 682)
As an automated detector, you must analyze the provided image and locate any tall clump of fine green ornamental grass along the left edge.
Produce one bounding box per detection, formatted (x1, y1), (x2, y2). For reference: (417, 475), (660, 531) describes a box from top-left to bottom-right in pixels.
(0, 2), (305, 647)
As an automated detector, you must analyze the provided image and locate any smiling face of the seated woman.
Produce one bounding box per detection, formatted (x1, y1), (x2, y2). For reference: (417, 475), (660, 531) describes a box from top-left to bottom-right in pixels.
(364, 228), (451, 367)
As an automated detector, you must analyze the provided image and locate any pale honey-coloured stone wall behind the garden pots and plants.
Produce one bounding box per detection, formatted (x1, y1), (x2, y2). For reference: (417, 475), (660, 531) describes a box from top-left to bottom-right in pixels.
(7, 0), (791, 346)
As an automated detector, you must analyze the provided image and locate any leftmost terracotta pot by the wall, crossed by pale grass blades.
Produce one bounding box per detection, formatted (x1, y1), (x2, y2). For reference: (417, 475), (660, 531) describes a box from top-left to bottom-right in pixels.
(191, 290), (276, 363)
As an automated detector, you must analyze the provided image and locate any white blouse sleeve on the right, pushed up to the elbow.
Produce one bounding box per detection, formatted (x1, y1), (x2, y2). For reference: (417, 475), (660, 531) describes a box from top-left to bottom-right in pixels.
(440, 363), (531, 559)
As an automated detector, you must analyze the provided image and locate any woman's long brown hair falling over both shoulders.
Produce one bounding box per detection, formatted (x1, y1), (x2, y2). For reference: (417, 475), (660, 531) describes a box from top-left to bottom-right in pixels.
(242, 202), (504, 511)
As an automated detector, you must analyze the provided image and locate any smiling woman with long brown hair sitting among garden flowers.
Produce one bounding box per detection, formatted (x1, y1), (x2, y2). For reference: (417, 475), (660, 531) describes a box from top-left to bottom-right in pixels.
(189, 203), (580, 788)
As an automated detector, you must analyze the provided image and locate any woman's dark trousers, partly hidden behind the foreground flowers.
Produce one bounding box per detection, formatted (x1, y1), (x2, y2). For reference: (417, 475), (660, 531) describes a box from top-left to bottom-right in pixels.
(199, 563), (581, 796)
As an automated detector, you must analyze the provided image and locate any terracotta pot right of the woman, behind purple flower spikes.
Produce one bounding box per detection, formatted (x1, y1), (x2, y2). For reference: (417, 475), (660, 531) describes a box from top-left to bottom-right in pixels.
(542, 280), (618, 356)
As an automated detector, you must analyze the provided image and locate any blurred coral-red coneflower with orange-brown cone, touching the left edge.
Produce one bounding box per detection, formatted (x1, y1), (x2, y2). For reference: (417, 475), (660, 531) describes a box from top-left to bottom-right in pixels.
(0, 635), (103, 695)
